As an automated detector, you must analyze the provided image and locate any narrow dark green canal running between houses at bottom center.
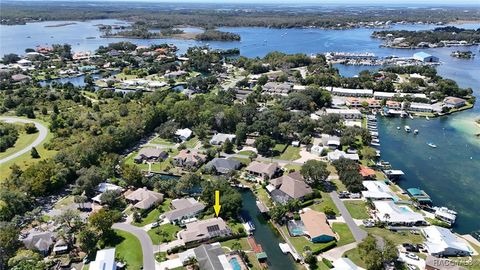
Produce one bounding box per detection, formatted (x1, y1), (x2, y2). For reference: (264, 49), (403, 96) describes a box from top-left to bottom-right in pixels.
(241, 190), (295, 270)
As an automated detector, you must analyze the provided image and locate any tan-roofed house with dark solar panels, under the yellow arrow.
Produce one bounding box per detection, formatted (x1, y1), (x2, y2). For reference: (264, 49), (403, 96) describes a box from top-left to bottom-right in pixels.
(178, 218), (232, 243)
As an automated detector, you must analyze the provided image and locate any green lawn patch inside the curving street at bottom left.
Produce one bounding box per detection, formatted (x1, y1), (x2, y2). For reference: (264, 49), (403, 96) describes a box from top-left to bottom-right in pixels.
(115, 230), (143, 270)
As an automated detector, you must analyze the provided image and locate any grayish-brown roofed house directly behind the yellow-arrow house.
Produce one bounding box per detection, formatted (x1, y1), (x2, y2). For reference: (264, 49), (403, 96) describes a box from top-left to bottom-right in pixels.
(160, 198), (205, 225)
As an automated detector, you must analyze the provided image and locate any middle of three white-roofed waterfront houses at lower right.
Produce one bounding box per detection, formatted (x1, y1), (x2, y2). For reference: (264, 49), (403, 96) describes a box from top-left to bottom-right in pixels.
(373, 201), (425, 223)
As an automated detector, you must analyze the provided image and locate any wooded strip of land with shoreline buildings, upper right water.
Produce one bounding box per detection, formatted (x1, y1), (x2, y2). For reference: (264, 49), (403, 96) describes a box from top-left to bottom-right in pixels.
(372, 26), (480, 49)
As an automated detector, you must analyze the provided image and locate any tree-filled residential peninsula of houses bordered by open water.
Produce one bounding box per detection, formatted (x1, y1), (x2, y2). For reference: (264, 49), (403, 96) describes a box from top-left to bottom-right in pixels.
(0, 16), (480, 270)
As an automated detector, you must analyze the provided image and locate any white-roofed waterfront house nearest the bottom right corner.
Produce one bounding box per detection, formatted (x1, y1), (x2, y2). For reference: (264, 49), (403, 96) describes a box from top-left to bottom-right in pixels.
(422, 226), (472, 254)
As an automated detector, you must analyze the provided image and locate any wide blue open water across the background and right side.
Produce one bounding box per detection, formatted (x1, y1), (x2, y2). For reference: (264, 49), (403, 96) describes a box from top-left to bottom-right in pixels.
(0, 20), (480, 234)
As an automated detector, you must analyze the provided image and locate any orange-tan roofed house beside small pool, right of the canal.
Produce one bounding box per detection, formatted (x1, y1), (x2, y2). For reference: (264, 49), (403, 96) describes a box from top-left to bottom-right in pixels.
(300, 209), (335, 243)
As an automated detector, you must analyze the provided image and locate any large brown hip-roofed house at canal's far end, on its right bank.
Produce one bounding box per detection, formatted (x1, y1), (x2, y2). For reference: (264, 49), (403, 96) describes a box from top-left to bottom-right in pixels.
(267, 172), (313, 204)
